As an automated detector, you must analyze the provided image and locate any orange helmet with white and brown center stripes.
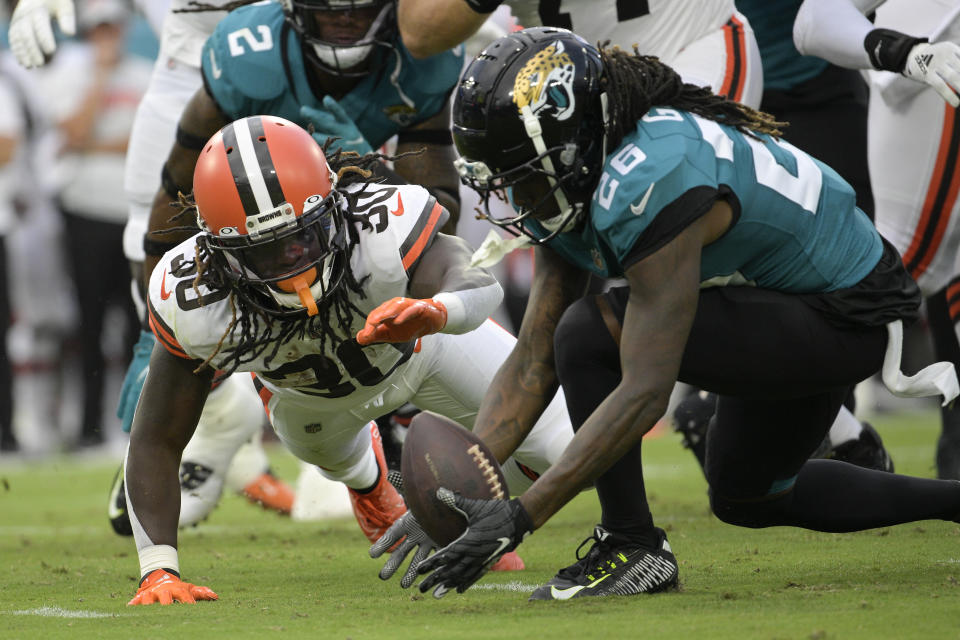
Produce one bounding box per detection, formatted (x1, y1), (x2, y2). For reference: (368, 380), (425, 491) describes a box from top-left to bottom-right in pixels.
(193, 116), (348, 316)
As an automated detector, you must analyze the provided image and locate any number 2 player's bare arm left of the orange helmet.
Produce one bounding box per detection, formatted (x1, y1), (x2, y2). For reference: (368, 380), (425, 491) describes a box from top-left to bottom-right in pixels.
(143, 87), (228, 288)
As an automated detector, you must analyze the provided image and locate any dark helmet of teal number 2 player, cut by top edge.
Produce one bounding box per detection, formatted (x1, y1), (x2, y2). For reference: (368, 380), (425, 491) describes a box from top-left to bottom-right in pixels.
(282, 0), (398, 77)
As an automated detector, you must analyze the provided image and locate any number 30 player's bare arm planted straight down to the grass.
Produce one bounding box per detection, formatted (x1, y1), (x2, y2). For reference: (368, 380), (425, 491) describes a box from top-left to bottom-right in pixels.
(126, 344), (213, 547)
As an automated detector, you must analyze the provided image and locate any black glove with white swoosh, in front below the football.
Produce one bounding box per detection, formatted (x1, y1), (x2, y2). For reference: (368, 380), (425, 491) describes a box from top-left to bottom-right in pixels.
(417, 487), (533, 598)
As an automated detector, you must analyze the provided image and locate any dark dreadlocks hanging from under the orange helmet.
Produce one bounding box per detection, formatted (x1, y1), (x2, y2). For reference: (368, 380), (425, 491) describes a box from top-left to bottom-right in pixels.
(174, 138), (419, 373)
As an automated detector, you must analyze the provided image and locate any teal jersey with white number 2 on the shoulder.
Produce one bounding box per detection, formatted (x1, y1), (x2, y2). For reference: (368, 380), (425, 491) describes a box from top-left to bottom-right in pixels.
(201, 2), (463, 148)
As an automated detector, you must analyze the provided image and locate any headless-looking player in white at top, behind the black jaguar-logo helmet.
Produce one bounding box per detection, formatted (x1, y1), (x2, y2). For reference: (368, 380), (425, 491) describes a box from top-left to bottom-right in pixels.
(397, 0), (763, 107)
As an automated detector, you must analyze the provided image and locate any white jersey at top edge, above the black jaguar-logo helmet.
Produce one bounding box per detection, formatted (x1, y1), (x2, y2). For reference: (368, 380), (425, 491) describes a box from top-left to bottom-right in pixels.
(507, 0), (735, 64)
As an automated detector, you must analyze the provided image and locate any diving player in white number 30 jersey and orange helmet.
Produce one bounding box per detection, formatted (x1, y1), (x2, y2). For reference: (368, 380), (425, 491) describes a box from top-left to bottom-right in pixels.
(125, 116), (573, 604)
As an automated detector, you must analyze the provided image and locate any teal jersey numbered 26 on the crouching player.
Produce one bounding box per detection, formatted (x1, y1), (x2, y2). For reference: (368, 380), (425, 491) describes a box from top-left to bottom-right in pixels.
(536, 108), (882, 293)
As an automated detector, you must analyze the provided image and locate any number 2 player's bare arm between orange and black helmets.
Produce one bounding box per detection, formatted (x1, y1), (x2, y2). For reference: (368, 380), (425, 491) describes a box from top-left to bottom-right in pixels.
(394, 109), (460, 235)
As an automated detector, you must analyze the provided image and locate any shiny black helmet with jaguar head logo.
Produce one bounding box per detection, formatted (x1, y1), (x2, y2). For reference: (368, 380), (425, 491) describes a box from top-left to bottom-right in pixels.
(453, 27), (607, 243)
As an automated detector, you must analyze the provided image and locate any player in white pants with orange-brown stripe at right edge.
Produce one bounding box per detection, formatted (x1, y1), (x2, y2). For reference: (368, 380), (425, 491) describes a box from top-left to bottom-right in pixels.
(794, 0), (960, 479)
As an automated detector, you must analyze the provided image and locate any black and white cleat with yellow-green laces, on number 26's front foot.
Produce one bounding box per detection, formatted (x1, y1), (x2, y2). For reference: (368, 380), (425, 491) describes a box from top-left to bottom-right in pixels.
(530, 526), (679, 600)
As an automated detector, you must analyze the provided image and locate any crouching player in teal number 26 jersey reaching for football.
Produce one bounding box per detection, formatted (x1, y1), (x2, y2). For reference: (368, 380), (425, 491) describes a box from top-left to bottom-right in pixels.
(419, 28), (960, 600)
